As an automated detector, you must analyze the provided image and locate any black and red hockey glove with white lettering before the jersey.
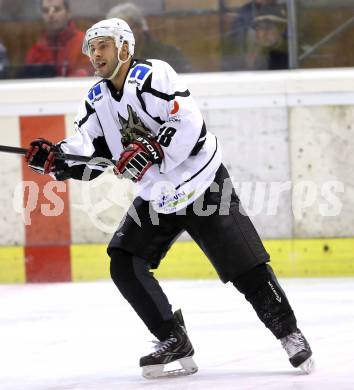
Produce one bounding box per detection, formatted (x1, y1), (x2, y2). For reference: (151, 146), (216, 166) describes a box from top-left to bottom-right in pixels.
(115, 135), (164, 182)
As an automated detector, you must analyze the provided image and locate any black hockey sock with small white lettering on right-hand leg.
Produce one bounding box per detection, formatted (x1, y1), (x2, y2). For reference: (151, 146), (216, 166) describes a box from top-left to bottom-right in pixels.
(232, 264), (297, 339)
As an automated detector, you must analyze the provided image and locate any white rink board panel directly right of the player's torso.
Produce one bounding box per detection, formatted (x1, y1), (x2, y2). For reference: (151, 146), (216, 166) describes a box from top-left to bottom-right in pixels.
(206, 107), (293, 238)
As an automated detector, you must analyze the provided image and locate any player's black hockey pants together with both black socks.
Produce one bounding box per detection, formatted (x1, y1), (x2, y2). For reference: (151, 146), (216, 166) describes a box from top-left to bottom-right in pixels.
(108, 165), (296, 340)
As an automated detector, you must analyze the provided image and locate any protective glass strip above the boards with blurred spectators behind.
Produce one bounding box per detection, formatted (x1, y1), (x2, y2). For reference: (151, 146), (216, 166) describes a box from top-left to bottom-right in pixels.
(0, 0), (354, 79)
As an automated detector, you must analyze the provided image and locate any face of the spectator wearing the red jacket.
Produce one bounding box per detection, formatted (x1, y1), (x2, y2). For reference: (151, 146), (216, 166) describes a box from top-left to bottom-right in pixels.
(42, 0), (70, 33)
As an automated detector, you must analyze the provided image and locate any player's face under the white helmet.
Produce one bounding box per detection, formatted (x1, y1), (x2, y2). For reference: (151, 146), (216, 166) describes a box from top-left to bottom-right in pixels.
(89, 37), (118, 78)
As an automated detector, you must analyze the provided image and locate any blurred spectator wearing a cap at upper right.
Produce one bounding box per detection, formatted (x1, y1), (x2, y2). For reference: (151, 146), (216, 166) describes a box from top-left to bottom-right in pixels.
(245, 9), (289, 70)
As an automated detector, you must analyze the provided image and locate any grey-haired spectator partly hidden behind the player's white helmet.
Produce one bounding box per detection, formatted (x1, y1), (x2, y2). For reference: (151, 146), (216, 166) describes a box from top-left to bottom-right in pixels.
(106, 3), (191, 73)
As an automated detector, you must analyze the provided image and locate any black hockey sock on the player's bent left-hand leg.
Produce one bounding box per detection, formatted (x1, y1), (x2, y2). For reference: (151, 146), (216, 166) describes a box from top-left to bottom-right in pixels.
(110, 249), (175, 340)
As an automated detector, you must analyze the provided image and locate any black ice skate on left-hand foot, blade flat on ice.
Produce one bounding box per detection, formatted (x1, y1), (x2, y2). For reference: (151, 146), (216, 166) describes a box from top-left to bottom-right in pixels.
(140, 310), (198, 379)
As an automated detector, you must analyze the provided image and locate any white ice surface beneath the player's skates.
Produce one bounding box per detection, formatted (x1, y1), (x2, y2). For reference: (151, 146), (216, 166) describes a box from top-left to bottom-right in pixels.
(0, 278), (354, 390)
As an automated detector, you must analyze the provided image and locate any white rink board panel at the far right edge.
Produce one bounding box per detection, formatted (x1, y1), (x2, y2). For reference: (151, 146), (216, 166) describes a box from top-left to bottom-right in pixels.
(290, 105), (354, 237)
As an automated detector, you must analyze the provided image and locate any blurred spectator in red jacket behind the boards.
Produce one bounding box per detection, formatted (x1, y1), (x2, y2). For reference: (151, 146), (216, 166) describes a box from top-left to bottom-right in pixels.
(25, 0), (93, 77)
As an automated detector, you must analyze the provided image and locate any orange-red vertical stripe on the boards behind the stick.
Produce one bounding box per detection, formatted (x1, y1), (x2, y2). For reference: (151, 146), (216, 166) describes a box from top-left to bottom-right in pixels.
(20, 115), (71, 282)
